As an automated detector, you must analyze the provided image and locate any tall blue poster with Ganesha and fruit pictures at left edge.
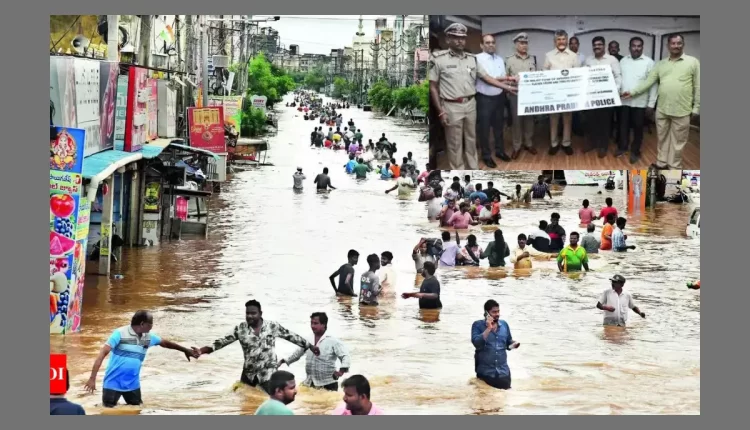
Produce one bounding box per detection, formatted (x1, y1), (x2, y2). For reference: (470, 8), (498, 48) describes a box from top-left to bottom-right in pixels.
(49, 127), (88, 333)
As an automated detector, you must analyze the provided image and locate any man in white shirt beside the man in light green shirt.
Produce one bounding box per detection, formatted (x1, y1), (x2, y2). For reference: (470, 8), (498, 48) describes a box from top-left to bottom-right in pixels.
(615, 36), (659, 164)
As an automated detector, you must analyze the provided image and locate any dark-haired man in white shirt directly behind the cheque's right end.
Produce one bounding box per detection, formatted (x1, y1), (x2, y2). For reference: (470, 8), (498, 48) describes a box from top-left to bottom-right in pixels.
(584, 36), (622, 158)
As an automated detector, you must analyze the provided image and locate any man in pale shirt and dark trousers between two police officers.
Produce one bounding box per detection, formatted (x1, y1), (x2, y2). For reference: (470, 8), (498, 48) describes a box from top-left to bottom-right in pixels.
(476, 34), (510, 169)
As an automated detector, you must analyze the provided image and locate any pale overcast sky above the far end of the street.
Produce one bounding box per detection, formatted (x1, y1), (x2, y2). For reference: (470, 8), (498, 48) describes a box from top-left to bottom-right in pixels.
(253, 15), (424, 55)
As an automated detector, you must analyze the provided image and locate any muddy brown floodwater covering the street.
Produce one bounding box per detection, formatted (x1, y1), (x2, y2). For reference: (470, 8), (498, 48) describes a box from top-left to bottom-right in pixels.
(50, 96), (700, 415)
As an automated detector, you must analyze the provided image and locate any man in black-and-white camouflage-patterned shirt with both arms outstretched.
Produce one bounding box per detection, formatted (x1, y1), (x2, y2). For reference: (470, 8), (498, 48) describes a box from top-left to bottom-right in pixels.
(199, 300), (320, 392)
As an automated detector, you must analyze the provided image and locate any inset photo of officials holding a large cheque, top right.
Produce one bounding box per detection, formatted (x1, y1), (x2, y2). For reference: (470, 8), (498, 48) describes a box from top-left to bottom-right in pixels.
(428, 15), (700, 170)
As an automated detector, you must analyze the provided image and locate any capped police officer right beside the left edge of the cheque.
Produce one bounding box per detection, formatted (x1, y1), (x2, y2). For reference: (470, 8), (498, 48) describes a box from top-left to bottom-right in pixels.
(505, 32), (536, 160)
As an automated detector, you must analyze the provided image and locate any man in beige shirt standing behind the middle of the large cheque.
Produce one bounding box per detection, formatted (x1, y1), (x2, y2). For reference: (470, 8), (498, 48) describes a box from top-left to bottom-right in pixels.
(544, 30), (581, 155)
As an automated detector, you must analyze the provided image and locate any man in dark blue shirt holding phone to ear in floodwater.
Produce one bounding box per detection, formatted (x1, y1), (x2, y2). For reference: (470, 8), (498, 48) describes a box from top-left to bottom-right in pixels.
(471, 299), (521, 390)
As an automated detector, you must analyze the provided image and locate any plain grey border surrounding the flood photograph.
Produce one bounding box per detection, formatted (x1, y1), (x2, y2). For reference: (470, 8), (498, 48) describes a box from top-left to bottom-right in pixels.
(19, 0), (748, 424)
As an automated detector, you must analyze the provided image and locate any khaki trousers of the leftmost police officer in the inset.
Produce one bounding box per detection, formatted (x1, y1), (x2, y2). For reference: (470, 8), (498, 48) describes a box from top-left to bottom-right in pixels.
(443, 97), (479, 170)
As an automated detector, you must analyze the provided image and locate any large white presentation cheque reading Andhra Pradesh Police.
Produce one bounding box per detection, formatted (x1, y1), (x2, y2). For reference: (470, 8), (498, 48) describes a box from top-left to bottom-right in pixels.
(518, 65), (621, 115)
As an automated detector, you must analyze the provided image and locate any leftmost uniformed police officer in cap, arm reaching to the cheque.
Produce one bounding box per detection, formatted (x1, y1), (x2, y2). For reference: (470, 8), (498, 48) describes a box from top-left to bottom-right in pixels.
(429, 23), (515, 170)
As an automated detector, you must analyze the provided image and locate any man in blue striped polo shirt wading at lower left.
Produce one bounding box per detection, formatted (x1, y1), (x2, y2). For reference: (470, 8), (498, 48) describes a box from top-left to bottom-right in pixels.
(85, 310), (200, 408)
